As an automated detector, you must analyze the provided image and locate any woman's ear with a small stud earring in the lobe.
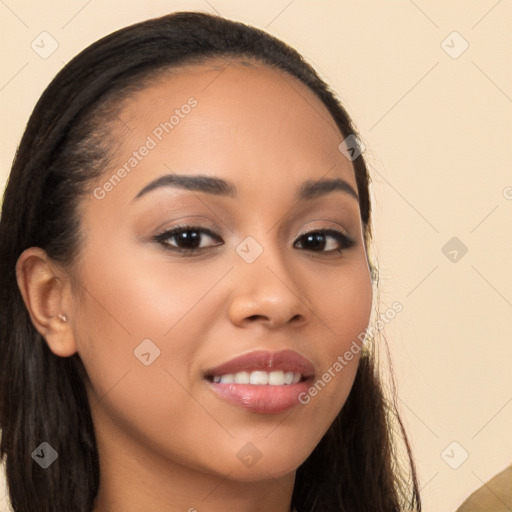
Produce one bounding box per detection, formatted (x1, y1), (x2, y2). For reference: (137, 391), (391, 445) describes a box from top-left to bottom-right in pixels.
(16, 247), (77, 357)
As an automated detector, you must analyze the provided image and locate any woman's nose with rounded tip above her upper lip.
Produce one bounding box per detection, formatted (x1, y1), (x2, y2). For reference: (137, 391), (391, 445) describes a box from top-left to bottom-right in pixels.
(229, 242), (312, 329)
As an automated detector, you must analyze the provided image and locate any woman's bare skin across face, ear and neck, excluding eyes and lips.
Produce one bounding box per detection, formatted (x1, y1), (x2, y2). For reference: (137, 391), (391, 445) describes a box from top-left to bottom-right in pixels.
(17, 61), (372, 512)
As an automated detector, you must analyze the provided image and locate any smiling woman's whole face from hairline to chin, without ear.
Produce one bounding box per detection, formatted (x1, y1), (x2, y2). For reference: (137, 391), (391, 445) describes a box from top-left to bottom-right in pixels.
(67, 62), (372, 481)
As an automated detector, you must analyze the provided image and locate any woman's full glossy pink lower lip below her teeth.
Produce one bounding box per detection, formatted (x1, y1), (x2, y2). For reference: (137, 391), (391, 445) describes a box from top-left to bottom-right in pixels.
(209, 380), (309, 414)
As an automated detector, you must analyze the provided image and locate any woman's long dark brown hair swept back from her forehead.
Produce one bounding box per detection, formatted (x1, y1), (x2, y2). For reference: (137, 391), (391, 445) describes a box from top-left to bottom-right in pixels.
(0, 12), (421, 512)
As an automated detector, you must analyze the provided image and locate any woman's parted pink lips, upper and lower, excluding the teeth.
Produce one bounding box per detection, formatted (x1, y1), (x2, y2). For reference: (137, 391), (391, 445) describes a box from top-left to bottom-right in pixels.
(204, 350), (315, 414)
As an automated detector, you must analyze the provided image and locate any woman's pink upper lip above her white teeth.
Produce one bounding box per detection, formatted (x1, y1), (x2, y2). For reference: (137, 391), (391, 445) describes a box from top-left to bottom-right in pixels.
(205, 350), (315, 378)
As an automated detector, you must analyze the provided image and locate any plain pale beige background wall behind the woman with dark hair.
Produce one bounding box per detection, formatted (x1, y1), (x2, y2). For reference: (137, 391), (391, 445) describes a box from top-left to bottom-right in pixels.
(0, 0), (512, 512)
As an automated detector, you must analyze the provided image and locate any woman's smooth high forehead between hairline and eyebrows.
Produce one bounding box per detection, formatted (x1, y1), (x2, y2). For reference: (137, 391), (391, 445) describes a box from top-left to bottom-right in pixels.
(95, 59), (355, 204)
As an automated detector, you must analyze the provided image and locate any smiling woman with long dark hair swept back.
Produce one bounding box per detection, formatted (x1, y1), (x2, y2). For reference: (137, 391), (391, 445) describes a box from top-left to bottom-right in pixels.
(0, 12), (420, 512)
